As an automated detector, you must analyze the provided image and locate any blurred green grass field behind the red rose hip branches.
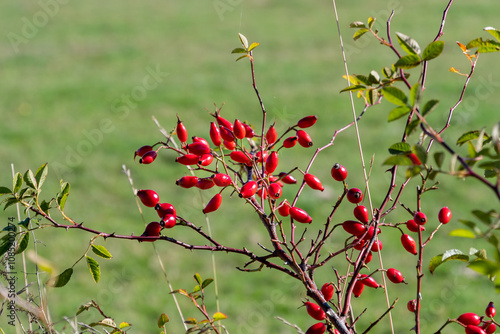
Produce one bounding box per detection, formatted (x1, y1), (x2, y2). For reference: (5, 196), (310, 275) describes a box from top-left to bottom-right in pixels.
(0, 0), (500, 334)
